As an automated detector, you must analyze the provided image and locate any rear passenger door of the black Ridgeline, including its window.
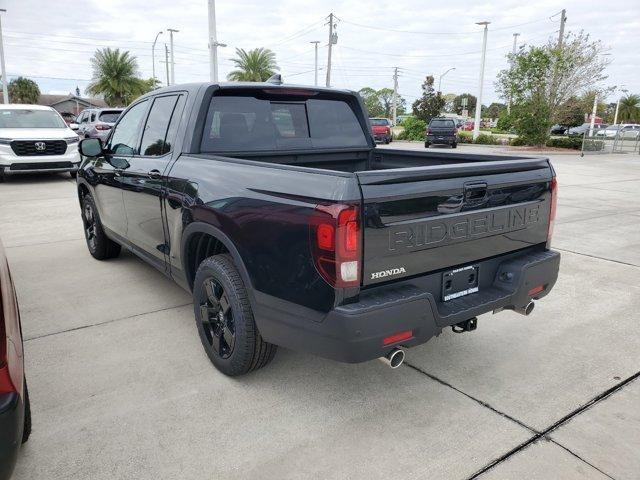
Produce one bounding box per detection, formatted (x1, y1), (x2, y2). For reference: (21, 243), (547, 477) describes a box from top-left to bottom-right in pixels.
(123, 94), (184, 269)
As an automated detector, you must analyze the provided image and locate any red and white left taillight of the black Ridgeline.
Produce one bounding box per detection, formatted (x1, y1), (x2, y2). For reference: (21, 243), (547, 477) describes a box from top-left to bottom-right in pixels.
(310, 204), (362, 288)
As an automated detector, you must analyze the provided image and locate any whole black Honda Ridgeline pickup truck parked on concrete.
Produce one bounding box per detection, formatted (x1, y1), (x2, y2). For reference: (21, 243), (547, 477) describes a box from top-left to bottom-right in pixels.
(78, 82), (560, 375)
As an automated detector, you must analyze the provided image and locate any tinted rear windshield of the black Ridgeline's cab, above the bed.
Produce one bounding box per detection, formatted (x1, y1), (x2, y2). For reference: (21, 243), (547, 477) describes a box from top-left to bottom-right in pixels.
(201, 96), (367, 152)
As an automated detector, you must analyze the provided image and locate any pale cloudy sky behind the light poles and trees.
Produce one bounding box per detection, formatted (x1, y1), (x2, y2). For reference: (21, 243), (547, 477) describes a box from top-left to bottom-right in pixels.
(0, 0), (640, 104)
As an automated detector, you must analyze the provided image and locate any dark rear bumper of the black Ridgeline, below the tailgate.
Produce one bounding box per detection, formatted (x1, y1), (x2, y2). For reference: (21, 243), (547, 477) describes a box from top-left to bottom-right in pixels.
(255, 250), (560, 363)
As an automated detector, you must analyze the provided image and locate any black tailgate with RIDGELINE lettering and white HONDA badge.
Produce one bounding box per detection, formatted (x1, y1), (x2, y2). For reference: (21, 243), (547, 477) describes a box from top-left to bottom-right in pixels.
(357, 159), (553, 286)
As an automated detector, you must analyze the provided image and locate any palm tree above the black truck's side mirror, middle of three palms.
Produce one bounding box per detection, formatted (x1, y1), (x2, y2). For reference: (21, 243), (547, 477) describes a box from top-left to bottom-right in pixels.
(87, 47), (151, 107)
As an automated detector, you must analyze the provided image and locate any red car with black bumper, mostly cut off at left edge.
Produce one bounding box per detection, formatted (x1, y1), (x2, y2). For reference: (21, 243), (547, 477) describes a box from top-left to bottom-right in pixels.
(0, 236), (31, 480)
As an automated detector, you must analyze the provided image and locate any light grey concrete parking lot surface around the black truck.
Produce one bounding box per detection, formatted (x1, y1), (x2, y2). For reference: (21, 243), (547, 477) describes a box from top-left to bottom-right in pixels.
(0, 143), (640, 480)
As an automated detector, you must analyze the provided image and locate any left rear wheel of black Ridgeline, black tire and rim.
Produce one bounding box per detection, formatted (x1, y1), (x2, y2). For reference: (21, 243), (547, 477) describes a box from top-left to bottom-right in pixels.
(193, 254), (278, 377)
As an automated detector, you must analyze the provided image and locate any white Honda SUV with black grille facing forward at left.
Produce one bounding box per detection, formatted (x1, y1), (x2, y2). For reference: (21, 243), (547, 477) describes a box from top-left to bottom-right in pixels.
(0, 105), (80, 182)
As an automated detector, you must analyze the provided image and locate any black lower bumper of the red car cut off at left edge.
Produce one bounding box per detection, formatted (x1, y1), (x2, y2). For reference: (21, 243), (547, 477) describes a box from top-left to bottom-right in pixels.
(0, 393), (24, 480)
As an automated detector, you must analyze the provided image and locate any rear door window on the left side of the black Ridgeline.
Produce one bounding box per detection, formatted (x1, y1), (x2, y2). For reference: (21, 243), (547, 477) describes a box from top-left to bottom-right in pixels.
(140, 95), (184, 156)
